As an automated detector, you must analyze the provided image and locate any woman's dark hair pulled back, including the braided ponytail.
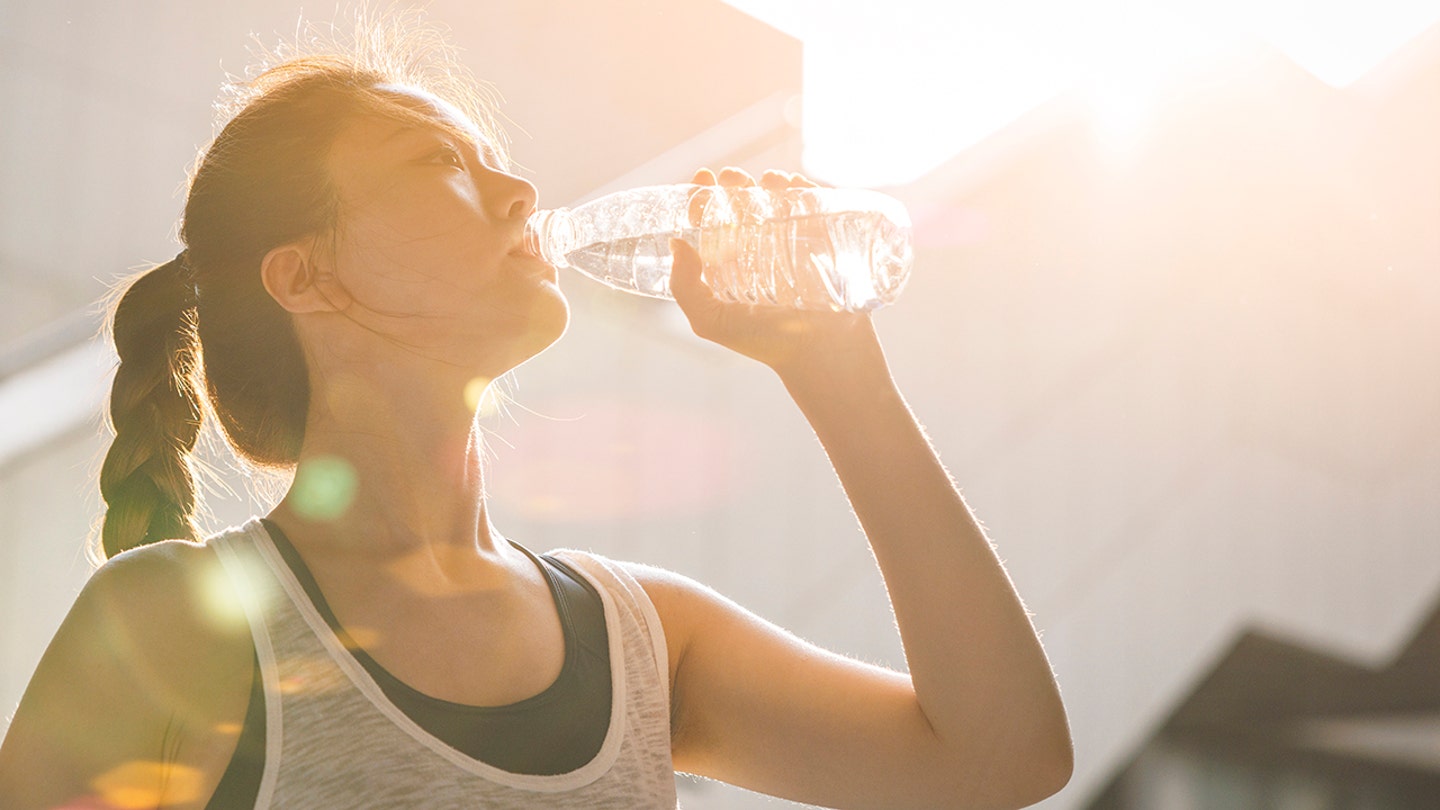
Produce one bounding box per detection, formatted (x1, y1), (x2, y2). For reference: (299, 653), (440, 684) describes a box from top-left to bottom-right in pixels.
(98, 14), (505, 558)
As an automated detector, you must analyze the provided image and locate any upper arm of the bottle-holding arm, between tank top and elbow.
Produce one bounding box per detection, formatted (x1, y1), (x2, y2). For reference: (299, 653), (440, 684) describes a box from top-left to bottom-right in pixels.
(629, 565), (984, 809)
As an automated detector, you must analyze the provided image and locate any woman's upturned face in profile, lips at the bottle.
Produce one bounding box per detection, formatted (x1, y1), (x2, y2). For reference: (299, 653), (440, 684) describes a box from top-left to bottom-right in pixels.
(318, 86), (569, 379)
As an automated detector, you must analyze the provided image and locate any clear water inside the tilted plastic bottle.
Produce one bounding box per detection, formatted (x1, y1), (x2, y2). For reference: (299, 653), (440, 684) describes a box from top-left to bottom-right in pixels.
(564, 212), (910, 310)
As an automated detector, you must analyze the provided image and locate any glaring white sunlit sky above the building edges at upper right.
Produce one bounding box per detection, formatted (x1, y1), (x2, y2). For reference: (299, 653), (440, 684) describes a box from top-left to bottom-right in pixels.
(726, 0), (1440, 186)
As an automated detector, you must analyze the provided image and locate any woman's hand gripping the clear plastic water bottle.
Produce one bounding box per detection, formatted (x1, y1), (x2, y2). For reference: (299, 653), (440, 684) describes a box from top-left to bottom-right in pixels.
(670, 169), (883, 380)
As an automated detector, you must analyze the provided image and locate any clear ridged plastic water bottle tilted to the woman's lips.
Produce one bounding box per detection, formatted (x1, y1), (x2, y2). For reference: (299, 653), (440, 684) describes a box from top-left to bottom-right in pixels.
(526, 184), (913, 311)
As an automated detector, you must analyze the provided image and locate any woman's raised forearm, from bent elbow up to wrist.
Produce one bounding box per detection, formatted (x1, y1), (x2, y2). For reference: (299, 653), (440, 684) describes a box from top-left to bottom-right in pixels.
(776, 333), (1071, 783)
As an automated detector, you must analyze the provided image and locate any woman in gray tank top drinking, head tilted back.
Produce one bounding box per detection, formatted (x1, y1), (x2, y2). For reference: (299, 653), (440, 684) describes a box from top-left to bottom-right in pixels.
(0, 20), (1071, 810)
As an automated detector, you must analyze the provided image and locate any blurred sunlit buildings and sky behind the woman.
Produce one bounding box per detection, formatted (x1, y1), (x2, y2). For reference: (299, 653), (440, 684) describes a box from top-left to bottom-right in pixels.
(0, 0), (1440, 810)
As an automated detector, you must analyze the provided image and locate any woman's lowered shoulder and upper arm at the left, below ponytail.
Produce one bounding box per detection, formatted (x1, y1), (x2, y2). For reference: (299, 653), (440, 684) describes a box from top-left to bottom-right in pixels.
(0, 543), (253, 809)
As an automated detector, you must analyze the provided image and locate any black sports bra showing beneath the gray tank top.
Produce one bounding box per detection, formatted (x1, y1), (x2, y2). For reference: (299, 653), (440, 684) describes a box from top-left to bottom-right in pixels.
(206, 519), (611, 810)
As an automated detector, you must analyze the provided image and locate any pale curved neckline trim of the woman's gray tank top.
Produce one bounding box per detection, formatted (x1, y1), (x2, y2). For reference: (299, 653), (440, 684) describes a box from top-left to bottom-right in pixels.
(241, 519), (626, 791)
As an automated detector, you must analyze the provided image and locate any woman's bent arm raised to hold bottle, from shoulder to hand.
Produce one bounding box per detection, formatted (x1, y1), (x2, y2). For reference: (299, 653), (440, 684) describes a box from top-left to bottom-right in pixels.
(630, 197), (1073, 809)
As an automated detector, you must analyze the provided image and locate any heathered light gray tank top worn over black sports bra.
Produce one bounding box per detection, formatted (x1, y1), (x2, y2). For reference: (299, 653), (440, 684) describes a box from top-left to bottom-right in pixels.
(207, 520), (678, 810)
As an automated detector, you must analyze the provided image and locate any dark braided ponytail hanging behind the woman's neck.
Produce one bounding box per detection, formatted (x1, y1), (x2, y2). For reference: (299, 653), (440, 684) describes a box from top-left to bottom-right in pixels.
(99, 252), (202, 558)
